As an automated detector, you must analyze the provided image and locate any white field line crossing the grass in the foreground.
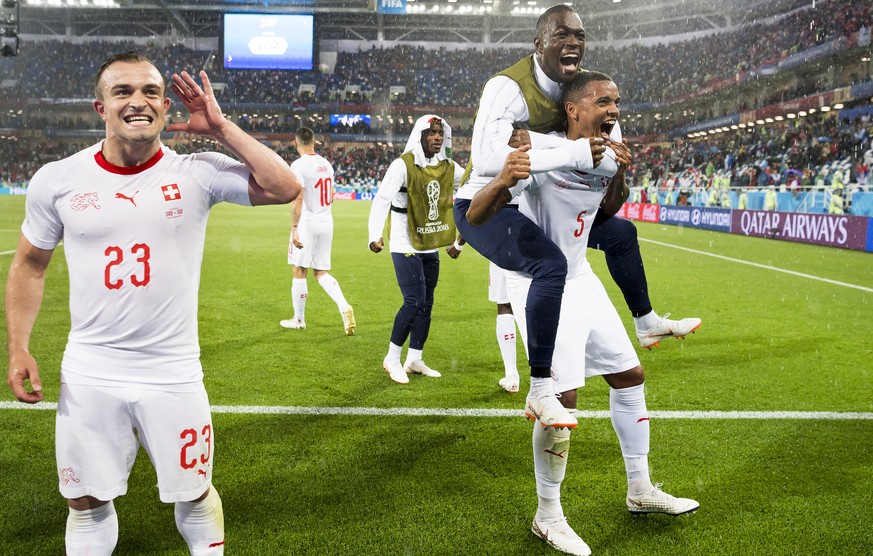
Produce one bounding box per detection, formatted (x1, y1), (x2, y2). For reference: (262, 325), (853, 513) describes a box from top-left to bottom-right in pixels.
(0, 402), (873, 421)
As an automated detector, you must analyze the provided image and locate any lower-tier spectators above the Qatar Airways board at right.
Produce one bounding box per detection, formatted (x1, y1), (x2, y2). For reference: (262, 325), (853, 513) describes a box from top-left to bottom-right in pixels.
(629, 110), (873, 206)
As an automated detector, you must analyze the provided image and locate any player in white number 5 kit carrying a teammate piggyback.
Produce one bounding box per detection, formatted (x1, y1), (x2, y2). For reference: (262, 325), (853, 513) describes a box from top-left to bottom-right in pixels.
(468, 72), (699, 555)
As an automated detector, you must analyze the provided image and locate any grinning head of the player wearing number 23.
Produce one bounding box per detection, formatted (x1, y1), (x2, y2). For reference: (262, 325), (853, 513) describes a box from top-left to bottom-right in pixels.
(94, 61), (170, 145)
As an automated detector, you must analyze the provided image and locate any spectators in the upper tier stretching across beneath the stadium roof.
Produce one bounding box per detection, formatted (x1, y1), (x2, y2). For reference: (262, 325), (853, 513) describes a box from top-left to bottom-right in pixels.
(0, 0), (873, 109)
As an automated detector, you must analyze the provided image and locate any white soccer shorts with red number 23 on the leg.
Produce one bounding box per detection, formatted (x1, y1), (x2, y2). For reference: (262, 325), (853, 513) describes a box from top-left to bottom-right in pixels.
(55, 383), (215, 503)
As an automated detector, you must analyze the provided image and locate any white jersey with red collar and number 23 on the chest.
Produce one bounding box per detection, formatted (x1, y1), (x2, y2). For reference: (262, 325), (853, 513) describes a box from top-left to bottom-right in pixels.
(21, 143), (251, 391)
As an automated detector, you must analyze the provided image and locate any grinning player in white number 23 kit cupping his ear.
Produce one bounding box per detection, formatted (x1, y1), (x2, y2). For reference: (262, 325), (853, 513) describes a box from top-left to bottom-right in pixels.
(6, 52), (301, 556)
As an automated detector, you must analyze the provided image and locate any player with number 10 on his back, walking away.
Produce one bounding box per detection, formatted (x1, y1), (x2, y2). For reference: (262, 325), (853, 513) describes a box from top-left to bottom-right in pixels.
(279, 127), (355, 336)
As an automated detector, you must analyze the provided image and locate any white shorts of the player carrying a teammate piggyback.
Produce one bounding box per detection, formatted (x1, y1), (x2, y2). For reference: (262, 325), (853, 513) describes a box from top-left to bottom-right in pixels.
(506, 268), (640, 392)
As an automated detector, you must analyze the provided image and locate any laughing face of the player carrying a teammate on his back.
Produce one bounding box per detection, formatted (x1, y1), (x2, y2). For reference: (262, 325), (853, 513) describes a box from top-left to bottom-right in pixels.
(564, 80), (621, 139)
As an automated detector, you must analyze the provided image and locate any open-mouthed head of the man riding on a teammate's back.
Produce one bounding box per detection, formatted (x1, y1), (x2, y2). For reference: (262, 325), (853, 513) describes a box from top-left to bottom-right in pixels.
(534, 10), (585, 83)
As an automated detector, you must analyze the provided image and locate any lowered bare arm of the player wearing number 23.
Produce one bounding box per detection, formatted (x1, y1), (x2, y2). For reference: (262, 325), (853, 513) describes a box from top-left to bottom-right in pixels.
(6, 235), (54, 403)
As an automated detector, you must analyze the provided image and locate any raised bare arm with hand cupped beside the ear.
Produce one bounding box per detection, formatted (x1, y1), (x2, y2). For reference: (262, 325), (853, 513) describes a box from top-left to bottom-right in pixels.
(167, 71), (302, 205)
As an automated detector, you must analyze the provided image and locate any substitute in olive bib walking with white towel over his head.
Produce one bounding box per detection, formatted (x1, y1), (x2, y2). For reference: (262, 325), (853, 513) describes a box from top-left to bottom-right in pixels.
(368, 114), (464, 384)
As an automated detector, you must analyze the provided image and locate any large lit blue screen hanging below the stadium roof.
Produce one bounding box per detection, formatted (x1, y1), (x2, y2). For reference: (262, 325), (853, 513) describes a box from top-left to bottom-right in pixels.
(221, 12), (315, 70)
